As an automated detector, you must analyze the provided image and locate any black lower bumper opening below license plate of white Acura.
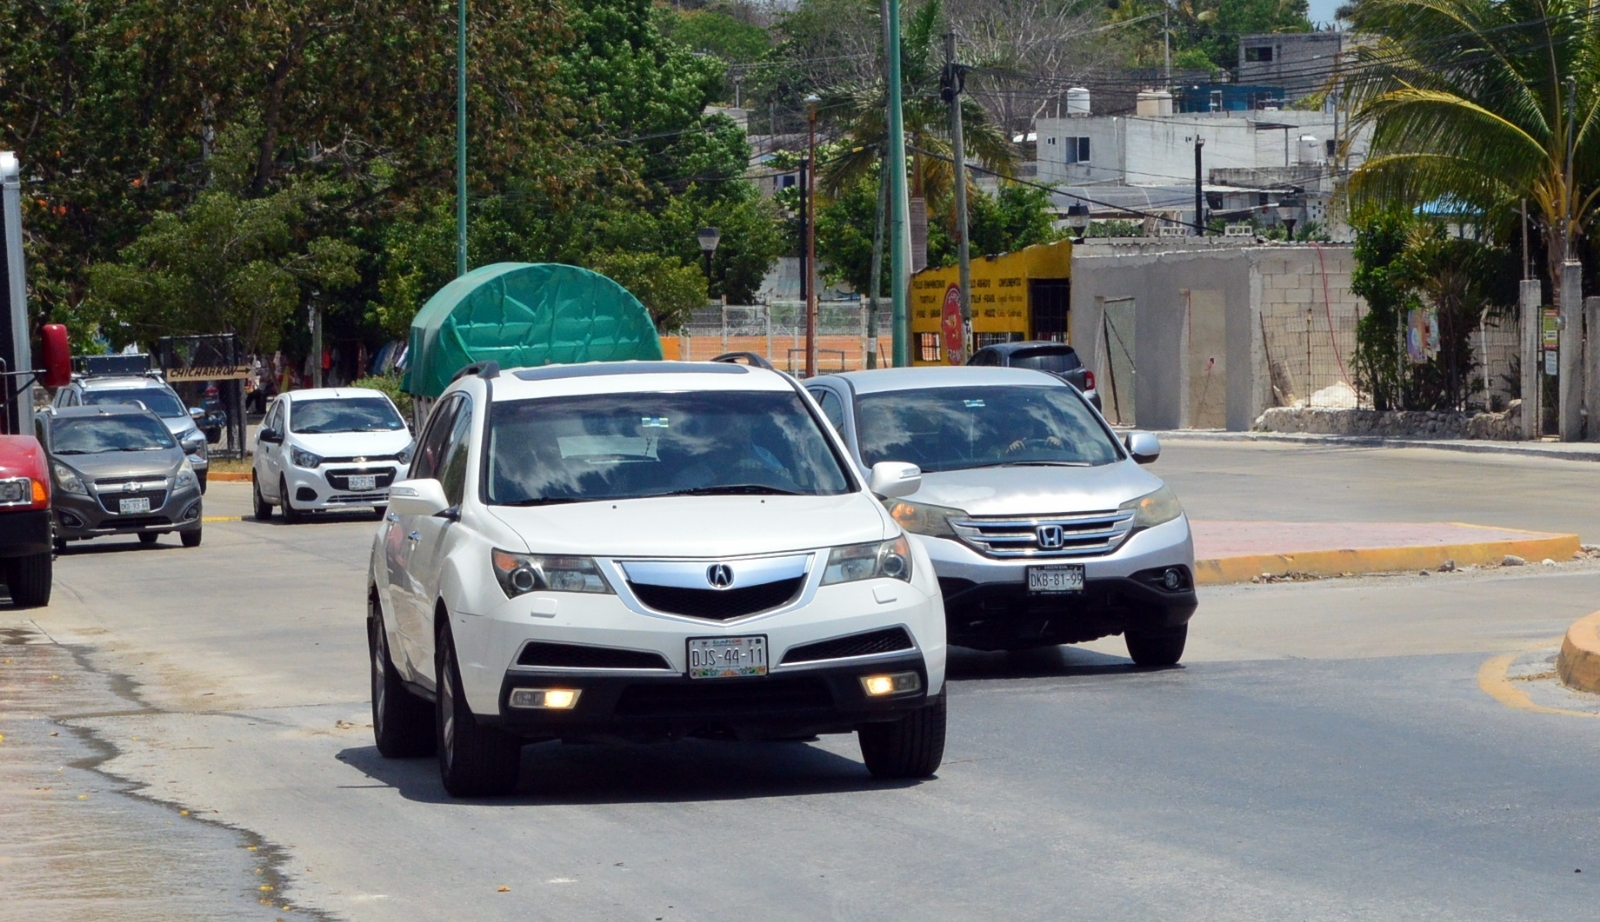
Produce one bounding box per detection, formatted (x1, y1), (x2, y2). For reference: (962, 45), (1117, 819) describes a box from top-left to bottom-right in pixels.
(614, 677), (834, 719)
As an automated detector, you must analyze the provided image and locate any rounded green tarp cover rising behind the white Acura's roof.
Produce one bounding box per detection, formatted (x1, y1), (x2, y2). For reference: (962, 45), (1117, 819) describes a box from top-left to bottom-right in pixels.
(402, 263), (661, 399)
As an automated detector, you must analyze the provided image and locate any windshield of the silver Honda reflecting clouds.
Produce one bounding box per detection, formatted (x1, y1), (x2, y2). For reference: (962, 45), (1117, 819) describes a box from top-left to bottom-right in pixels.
(856, 386), (1122, 472)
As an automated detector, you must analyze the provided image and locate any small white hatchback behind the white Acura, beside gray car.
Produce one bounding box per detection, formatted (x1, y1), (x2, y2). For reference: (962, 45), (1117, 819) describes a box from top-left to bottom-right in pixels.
(250, 387), (411, 522)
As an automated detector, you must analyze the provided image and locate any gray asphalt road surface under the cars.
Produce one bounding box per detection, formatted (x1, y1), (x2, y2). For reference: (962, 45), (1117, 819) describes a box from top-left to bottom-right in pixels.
(0, 445), (1600, 920)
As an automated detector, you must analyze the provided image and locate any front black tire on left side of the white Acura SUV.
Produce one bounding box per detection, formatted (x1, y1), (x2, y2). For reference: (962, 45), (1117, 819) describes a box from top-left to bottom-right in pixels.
(434, 626), (522, 797)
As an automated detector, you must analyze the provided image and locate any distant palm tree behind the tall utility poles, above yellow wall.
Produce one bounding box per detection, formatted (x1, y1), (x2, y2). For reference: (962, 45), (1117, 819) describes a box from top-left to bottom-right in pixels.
(818, 0), (1018, 200)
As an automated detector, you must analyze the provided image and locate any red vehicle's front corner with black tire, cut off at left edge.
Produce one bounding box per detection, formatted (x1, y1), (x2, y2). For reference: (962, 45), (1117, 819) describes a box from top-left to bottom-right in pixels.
(0, 435), (53, 608)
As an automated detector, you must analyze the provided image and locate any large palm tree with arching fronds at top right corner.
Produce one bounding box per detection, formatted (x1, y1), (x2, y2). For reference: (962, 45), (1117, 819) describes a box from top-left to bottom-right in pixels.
(1341, 0), (1600, 302)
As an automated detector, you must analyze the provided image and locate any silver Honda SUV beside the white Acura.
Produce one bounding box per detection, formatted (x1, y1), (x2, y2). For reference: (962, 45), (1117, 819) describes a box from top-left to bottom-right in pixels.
(806, 367), (1197, 666)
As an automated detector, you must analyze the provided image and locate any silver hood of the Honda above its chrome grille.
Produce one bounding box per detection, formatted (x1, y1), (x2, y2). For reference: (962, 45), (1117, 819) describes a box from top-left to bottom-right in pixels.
(906, 461), (1162, 515)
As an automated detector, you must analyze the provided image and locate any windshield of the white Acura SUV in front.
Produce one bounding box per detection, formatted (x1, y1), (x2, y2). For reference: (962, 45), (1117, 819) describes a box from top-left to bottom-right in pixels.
(486, 391), (851, 505)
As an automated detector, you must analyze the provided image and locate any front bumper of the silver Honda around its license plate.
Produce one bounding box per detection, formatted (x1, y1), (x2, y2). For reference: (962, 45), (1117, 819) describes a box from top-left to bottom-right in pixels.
(922, 517), (1198, 650)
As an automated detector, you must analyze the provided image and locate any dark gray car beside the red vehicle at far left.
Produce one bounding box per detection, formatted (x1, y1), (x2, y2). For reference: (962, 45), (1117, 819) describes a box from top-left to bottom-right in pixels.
(37, 405), (202, 551)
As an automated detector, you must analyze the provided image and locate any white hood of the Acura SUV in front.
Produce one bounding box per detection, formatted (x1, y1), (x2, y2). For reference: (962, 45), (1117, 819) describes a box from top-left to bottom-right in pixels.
(488, 493), (898, 557)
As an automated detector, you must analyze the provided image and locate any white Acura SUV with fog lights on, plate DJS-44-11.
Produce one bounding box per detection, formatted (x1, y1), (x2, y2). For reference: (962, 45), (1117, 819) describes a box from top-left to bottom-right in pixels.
(368, 362), (946, 796)
